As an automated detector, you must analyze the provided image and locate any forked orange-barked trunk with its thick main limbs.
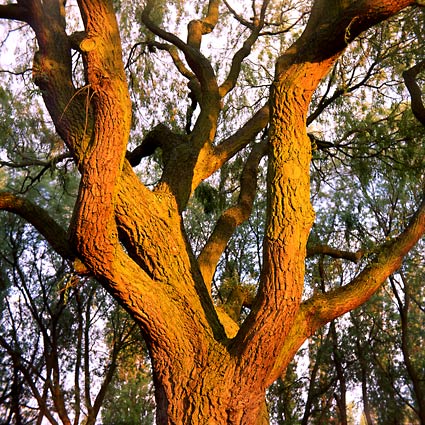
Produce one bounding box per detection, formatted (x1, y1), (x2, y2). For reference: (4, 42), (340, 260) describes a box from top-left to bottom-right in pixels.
(0, 0), (425, 425)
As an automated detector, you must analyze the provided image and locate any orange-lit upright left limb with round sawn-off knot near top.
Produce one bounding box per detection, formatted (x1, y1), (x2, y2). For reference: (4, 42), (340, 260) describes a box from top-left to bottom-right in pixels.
(71, 0), (131, 272)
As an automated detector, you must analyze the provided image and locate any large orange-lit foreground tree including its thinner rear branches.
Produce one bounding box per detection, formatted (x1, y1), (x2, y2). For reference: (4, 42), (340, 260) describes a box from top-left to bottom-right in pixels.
(0, 0), (425, 424)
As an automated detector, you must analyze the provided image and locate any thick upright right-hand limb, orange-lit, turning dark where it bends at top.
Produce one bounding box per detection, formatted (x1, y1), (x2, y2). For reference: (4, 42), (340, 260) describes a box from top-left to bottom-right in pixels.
(230, 0), (414, 387)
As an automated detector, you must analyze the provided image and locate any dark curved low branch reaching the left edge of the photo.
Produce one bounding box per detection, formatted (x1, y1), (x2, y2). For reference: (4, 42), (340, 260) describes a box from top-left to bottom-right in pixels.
(0, 192), (76, 260)
